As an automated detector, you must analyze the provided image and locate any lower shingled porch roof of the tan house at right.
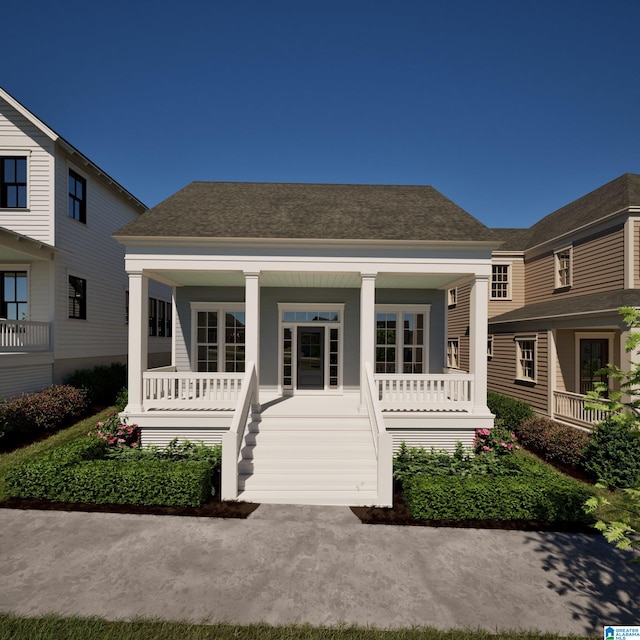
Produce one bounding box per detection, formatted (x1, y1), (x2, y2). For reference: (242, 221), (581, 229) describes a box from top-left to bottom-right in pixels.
(489, 289), (640, 325)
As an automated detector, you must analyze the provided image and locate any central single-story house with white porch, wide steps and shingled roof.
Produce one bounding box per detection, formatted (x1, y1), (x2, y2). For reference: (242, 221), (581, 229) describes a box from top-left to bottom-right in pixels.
(115, 182), (498, 505)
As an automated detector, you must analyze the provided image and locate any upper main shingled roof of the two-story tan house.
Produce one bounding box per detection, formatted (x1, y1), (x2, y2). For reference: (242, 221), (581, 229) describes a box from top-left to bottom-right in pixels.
(493, 173), (640, 251)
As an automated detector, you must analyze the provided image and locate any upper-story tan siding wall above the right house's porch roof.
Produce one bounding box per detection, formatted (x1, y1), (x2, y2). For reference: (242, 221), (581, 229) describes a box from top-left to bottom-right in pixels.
(526, 225), (624, 304)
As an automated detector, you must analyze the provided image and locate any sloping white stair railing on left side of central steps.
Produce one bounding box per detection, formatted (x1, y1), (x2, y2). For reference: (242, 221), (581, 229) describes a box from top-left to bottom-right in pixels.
(220, 362), (258, 500)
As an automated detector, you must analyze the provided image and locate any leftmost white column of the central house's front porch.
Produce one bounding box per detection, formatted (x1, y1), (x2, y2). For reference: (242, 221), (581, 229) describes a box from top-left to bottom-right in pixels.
(126, 273), (149, 413)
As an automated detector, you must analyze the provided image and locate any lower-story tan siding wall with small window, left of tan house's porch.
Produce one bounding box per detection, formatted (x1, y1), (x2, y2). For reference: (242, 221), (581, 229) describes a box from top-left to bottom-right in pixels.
(488, 331), (549, 414)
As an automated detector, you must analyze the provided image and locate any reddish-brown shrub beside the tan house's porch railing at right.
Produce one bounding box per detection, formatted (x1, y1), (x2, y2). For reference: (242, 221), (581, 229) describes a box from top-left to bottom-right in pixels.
(515, 416), (591, 469)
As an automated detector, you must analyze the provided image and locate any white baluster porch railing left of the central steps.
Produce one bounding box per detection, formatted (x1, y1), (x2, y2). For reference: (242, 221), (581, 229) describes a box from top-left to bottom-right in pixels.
(142, 367), (245, 411)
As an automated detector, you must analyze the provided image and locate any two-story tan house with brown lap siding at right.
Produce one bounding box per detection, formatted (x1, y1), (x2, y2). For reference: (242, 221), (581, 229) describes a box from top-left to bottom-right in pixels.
(448, 174), (640, 427)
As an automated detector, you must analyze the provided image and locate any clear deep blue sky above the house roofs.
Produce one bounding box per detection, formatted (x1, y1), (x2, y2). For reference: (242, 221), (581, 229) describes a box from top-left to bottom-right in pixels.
(0, 0), (640, 227)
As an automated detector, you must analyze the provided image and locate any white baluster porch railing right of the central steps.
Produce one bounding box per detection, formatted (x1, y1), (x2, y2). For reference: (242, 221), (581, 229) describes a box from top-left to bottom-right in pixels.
(374, 373), (473, 411)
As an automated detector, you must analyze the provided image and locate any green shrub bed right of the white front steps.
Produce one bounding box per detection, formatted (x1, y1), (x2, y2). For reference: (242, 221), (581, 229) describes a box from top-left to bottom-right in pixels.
(396, 447), (592, 523)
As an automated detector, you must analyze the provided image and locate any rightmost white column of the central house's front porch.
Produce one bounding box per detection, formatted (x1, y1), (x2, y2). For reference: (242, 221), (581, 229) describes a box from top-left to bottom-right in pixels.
(469, 276), (489, 413)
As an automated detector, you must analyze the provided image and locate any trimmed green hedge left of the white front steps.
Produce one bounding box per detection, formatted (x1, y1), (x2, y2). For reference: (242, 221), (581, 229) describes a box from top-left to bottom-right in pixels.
(5, 438), (212, 507)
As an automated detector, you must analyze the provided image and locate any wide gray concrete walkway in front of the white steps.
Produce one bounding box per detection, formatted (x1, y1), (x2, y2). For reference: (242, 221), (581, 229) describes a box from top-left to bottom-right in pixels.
(0, 505), (640, 637)
